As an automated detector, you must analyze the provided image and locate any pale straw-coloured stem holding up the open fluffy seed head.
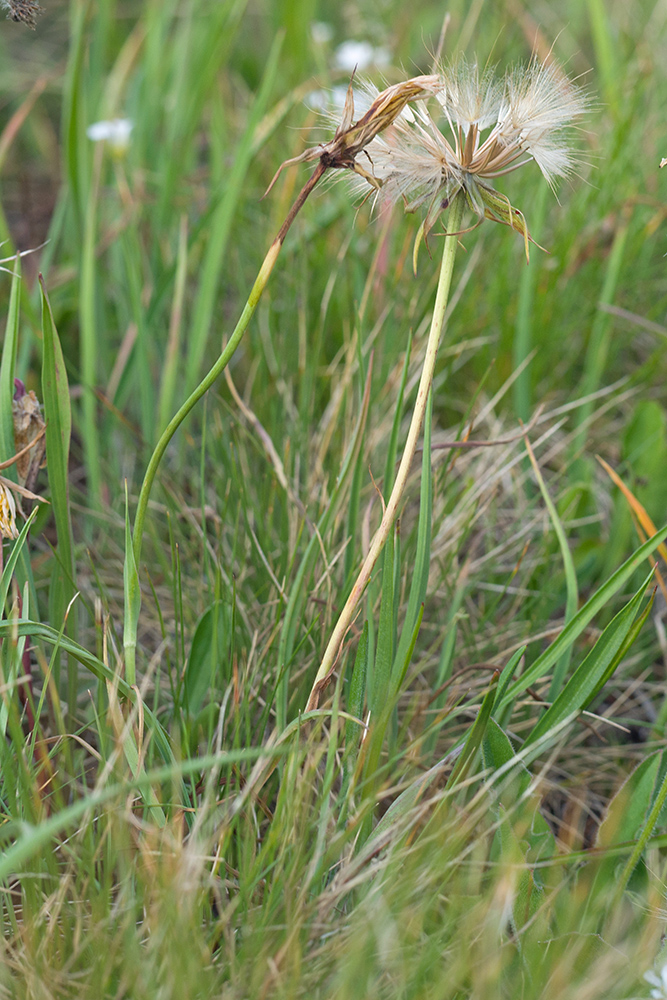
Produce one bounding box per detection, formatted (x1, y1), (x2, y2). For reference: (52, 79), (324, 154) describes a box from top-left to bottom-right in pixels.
(306, 193), (464, 712)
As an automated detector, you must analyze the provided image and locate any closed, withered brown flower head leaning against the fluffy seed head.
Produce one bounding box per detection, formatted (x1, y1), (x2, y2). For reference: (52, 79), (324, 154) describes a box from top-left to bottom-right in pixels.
(266, 75), (439, 194)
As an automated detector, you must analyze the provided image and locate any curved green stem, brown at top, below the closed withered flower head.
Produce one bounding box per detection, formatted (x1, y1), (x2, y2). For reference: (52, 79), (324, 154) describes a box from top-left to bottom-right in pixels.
(132, 161), (327, 566)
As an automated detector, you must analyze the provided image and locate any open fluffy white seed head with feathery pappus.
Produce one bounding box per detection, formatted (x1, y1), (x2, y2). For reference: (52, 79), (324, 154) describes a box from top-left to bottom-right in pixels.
(357, 60), (586, 249)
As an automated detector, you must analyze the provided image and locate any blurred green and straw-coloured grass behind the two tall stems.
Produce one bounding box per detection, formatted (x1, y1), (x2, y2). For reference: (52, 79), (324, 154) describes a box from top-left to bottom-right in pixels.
(0, 0), (667, 1000)
